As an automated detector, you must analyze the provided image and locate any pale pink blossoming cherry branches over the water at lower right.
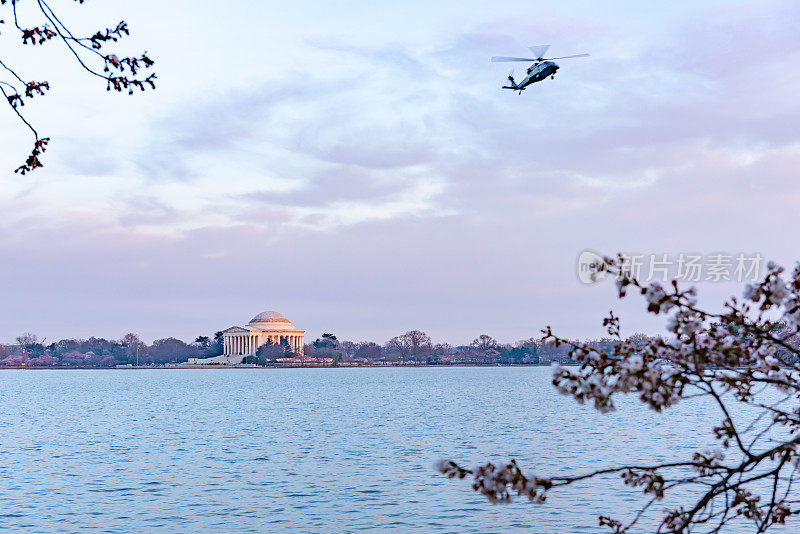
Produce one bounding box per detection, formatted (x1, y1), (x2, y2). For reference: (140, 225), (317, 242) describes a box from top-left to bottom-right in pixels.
(439, 258), (800, 533)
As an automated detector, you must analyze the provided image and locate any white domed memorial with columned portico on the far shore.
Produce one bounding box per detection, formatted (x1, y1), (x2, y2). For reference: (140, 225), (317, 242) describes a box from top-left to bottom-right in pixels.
(188, 311), (305, 365)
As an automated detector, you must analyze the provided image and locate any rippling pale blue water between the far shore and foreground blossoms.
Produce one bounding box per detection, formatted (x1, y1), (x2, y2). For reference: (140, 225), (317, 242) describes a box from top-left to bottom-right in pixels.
(0, 368), (788, 533)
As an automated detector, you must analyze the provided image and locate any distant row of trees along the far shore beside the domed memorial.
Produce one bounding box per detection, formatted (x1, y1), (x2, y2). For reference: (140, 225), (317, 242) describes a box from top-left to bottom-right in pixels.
(0, 330), (664, 368)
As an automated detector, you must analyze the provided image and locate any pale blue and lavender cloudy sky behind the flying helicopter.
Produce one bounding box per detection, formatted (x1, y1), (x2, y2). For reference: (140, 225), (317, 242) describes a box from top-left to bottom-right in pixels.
(0, 0), (800, 343)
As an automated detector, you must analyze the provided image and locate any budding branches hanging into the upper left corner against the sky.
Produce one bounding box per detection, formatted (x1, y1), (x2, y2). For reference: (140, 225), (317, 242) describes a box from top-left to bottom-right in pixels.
(0, 0), (156, 174)
